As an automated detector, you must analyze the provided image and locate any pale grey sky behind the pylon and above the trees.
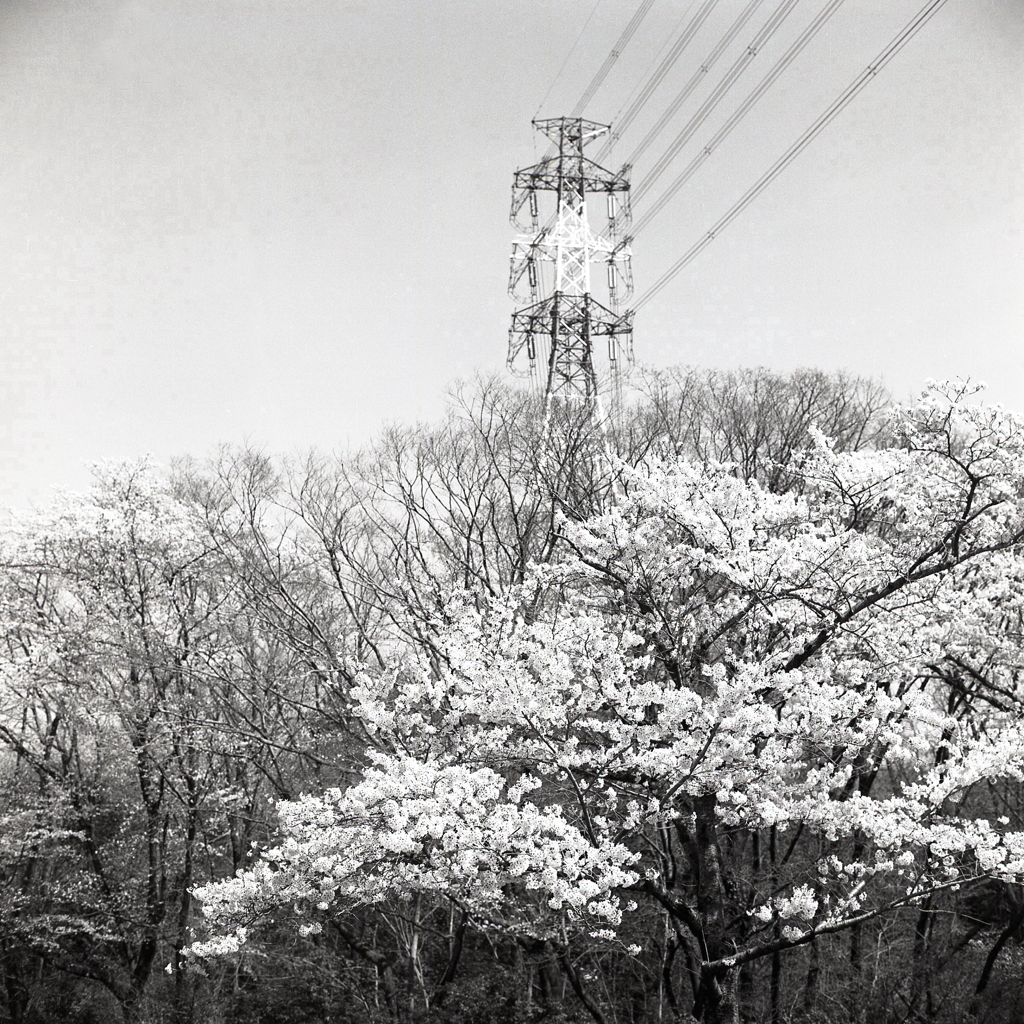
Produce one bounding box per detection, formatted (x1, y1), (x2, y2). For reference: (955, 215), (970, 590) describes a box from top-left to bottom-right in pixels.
(0, 0), (1024, 505)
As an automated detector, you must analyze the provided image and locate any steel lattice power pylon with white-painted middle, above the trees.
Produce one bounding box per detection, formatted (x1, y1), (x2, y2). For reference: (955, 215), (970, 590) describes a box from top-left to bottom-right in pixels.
(509, 118), (633, 418)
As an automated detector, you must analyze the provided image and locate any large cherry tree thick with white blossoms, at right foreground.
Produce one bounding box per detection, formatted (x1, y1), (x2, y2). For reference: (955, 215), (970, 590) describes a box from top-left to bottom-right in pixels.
(194, 386), (1024, 1022)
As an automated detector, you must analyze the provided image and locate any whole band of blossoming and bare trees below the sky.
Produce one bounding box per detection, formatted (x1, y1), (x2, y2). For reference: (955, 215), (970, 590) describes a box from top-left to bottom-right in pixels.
(0, 369), (1024, 1024)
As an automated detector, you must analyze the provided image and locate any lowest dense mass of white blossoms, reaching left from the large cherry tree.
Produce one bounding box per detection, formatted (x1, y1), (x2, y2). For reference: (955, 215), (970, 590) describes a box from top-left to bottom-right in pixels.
(197, 757), (636, 954)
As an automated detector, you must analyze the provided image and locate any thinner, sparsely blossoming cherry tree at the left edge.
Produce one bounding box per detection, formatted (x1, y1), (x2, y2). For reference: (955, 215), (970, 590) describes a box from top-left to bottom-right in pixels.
(0, 460), (327, 1022)
